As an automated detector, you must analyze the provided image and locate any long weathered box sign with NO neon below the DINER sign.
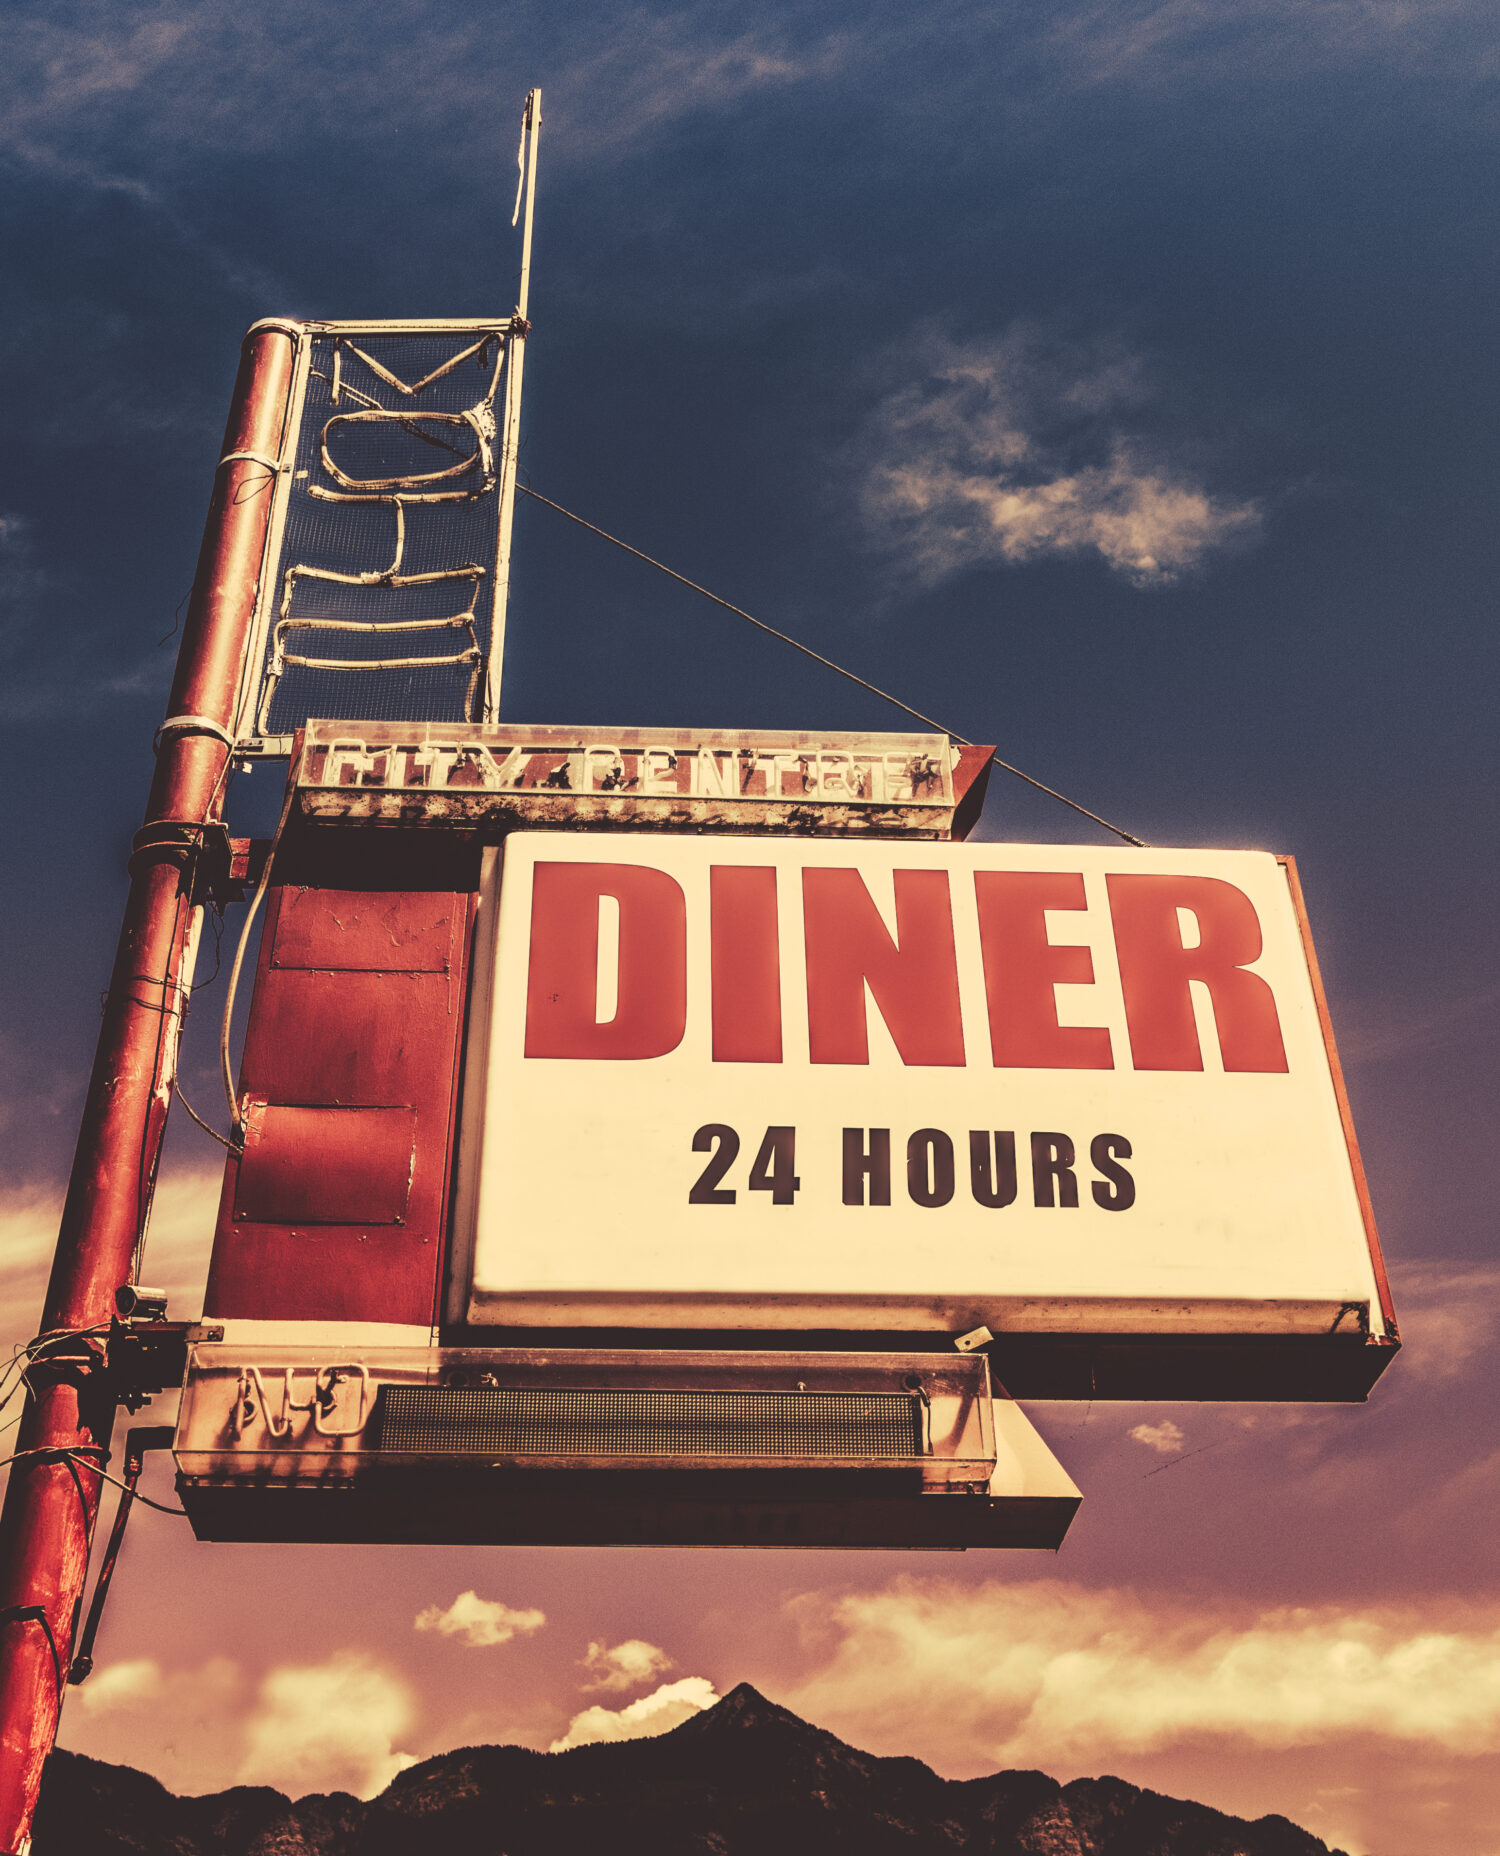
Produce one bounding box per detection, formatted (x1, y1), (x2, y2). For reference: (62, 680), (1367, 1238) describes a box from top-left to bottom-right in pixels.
(167, 1333), (1079, 1550)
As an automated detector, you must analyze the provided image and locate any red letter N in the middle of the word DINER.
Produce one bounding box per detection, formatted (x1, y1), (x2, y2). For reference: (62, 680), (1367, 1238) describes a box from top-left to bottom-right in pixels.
(802, 869), (963, 1065)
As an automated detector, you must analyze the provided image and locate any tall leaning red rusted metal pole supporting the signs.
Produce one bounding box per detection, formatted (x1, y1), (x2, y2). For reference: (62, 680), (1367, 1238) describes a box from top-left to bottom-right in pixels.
(0, 325), (295, 1856)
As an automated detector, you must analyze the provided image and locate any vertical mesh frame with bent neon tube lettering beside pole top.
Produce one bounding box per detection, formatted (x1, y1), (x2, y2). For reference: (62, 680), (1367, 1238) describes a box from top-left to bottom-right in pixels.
(241, 325), (509, 739)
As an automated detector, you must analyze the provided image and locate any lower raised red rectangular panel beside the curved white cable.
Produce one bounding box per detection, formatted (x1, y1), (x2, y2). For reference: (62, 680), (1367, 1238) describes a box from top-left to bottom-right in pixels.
(234, 1102), (416, 1225)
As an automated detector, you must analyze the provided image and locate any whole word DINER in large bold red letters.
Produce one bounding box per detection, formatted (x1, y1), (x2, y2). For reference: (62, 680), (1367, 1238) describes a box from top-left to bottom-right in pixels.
(525, 861), (1287, 1075)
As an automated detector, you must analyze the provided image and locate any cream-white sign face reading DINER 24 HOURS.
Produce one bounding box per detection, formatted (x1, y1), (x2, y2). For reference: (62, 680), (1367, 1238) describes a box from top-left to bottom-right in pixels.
(464, 831), (1385, 1334)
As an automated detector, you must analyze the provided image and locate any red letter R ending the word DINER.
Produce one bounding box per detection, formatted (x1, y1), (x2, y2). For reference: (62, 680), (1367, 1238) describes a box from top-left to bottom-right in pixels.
(1108, 876), (1287, 1071)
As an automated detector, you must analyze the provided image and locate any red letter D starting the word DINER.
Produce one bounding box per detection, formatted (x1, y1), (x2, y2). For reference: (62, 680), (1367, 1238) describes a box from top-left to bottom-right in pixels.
(525, 863), (687, 1060)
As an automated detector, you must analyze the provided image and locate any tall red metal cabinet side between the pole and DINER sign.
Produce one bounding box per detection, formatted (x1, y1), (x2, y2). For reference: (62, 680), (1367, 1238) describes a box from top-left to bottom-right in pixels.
(206, 831), (479, 1327)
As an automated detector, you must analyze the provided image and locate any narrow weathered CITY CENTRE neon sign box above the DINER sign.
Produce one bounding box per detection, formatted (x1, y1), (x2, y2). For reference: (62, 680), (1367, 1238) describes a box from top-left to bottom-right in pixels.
(297, 722), (991, 837)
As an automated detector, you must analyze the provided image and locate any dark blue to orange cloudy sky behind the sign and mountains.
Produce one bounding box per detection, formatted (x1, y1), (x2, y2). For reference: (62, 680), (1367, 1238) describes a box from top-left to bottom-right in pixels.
(0, 0), (1500, 1856)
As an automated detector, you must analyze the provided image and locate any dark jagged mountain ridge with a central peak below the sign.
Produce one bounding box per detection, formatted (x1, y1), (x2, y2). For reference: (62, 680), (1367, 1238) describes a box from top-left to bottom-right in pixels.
(32, 1683), (1344, 1856)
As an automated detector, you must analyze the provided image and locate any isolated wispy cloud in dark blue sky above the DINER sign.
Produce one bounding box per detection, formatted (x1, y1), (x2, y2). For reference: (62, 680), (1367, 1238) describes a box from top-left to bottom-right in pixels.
(856, 329), (1261, 586)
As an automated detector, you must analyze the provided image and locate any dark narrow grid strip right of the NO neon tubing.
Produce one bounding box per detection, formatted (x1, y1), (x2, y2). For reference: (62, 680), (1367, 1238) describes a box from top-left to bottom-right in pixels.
(377, 1385), (923, 1459)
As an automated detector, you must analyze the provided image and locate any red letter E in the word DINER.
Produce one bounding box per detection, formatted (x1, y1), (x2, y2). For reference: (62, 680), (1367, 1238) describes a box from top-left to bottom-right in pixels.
(975, 870), (1114, 1069)
